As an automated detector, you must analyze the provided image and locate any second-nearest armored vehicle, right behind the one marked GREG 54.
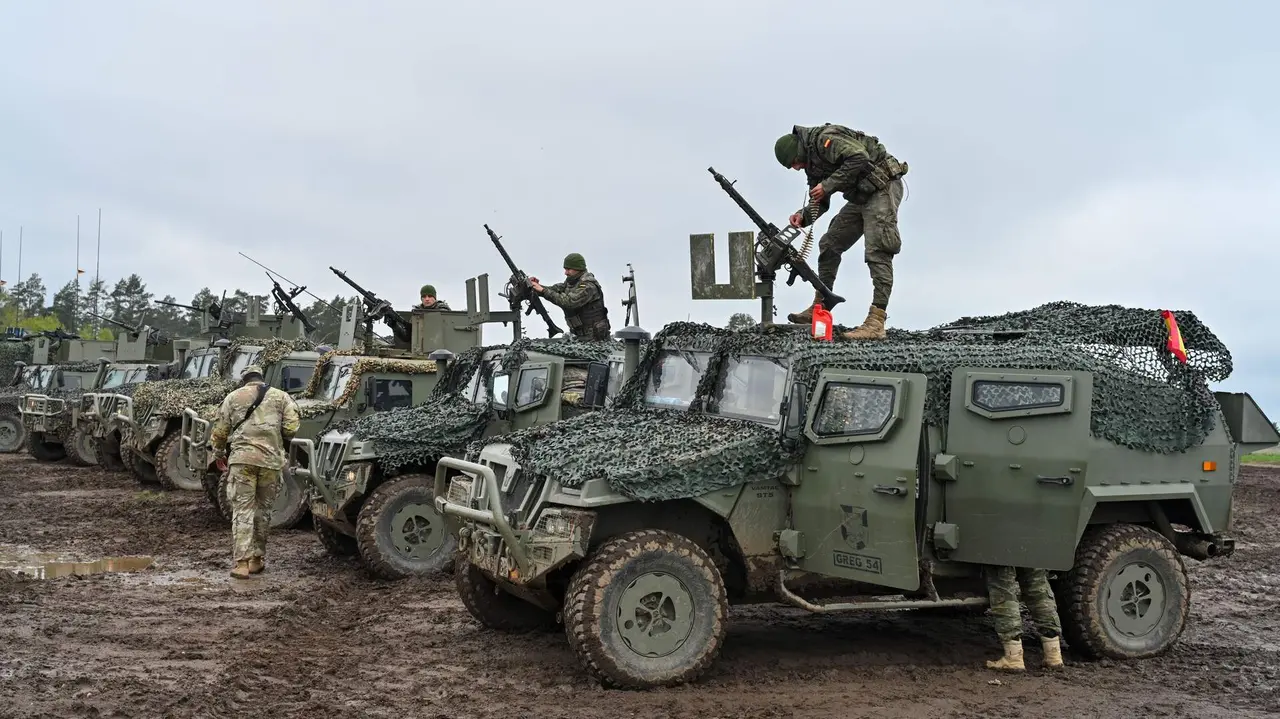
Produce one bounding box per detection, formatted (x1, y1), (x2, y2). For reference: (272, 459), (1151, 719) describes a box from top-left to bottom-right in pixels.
(289, 268), (635, 580)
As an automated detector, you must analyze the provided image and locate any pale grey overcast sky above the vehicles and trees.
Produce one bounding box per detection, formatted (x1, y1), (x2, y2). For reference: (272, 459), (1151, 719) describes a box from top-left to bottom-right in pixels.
(0, 0), (1280, 420)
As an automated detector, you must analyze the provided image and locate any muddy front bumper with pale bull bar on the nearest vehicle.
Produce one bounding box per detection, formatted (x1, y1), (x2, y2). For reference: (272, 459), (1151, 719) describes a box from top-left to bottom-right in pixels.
(435, 457), (595, 591)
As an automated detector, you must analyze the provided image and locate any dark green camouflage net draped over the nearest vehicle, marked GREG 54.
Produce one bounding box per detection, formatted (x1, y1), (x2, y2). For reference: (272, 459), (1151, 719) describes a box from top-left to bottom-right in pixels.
(468, 302), (1231, 500)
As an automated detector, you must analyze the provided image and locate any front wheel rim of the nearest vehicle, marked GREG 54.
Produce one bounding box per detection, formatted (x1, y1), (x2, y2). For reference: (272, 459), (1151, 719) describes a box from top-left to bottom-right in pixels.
(617, 572), (694, 658)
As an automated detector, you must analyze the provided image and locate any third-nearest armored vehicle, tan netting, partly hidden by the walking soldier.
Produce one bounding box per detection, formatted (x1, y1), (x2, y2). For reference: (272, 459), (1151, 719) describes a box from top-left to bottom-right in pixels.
(182, 275), (480, 528)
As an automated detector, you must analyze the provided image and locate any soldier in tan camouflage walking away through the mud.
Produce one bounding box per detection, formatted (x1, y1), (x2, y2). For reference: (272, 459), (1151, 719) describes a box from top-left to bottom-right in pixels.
(209, 365), (300, 580)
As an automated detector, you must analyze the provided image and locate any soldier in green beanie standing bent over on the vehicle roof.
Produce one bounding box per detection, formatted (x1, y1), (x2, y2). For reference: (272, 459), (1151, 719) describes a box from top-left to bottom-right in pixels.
(773, 123), (906, 339)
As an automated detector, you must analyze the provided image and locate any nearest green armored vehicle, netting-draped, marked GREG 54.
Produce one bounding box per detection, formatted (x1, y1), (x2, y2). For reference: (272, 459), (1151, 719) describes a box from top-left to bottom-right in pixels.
(434, 223), (1280, 688)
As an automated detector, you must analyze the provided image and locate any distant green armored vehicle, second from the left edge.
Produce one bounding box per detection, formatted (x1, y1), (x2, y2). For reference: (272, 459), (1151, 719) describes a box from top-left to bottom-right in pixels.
(22, 312), (180, 467)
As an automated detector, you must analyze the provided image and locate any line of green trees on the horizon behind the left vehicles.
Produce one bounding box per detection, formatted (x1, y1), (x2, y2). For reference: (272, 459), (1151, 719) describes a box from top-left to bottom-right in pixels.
(0, 273), (349, 342)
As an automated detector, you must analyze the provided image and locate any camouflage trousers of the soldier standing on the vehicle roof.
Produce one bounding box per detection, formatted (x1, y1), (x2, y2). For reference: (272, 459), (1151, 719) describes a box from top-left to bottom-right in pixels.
(818, 179), (902, 310)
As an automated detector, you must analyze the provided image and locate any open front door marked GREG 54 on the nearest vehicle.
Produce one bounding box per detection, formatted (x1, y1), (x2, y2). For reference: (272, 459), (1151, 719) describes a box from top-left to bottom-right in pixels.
(791, 370), (927, 590)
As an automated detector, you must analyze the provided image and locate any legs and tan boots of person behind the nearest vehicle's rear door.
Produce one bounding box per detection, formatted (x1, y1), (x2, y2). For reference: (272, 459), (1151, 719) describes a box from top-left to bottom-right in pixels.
(983, 567), (1062, 672)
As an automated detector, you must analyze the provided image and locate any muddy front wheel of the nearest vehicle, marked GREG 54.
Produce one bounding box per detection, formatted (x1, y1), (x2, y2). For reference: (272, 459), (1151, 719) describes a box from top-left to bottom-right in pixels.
(564, 530), (728, 690)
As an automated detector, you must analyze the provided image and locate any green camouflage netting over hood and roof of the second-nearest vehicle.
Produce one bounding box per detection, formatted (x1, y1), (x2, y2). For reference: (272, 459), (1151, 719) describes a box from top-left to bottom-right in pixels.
(334, 338), (622, 470)
